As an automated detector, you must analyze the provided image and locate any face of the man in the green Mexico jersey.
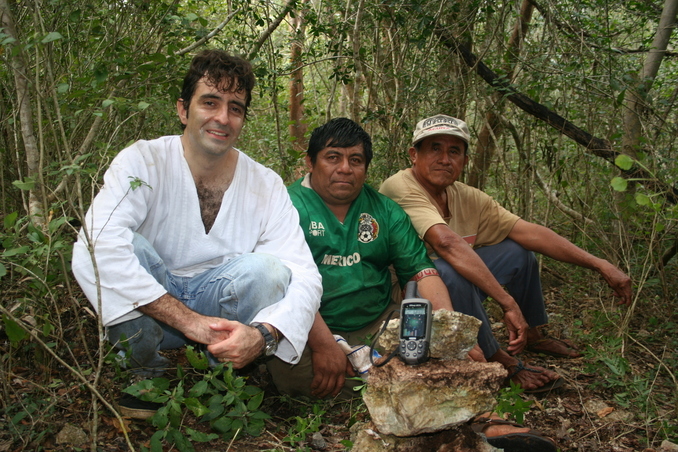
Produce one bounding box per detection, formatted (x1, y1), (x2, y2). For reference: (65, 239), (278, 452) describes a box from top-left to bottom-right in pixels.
(306, 143), (367, 207)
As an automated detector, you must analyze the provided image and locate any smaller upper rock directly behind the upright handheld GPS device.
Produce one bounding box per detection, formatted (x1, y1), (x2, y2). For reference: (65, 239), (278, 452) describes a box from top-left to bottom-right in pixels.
(379, 309), (482, 359)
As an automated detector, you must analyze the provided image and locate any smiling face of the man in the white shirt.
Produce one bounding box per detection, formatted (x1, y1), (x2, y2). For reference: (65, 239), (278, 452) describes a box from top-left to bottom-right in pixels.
(177, 78), (246, 157)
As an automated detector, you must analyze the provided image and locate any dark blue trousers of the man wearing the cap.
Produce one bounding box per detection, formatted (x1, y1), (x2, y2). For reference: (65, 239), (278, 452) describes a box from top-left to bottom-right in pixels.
(434, 239), (548, 358)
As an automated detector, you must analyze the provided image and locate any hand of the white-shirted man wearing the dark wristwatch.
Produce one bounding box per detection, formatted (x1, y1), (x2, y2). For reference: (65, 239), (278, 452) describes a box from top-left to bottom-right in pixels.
(207, 319), (265, 369)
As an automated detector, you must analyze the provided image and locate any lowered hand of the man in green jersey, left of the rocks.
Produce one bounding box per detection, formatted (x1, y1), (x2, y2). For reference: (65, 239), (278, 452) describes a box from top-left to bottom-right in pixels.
(311, 341), (355, 398)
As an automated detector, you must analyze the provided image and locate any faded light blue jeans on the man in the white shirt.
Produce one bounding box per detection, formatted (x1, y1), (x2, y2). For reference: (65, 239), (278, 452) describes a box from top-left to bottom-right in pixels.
(107, 234), (292, 377)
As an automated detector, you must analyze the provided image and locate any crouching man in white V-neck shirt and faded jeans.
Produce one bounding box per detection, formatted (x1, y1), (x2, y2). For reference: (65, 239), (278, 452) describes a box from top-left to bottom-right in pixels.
(73, 50), (322, 410)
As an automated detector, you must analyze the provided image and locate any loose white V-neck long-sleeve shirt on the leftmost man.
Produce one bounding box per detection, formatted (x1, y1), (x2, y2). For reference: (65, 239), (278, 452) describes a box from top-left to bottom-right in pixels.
(72, 136), (322, 363)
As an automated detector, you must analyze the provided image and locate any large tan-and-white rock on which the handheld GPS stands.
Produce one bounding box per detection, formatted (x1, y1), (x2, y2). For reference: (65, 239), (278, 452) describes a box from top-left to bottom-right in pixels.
(363, 358), (507, 436)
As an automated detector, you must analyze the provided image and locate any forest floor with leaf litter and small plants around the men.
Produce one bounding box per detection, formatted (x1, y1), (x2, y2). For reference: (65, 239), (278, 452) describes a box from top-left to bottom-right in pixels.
(0, 264), (678, 452)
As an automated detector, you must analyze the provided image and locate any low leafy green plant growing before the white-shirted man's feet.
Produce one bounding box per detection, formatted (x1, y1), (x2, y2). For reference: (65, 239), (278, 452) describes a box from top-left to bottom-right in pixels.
(124, 346), (270, 451)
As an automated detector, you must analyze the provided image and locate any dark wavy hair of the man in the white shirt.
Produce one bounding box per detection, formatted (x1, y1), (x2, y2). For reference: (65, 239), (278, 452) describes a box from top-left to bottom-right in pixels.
(181, 49), (255, 118)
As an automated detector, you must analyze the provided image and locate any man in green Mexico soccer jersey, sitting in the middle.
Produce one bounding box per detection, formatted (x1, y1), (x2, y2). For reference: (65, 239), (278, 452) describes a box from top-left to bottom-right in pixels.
(268, 118), (472, 397)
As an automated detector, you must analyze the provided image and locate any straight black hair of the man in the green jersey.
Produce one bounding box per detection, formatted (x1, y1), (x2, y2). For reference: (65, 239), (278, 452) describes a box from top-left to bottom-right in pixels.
(306, 118), (372, 169)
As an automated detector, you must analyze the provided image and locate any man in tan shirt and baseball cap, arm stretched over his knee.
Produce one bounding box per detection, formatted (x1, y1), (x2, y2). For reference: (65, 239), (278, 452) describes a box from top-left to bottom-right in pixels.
(380, 115), (632, 392)
